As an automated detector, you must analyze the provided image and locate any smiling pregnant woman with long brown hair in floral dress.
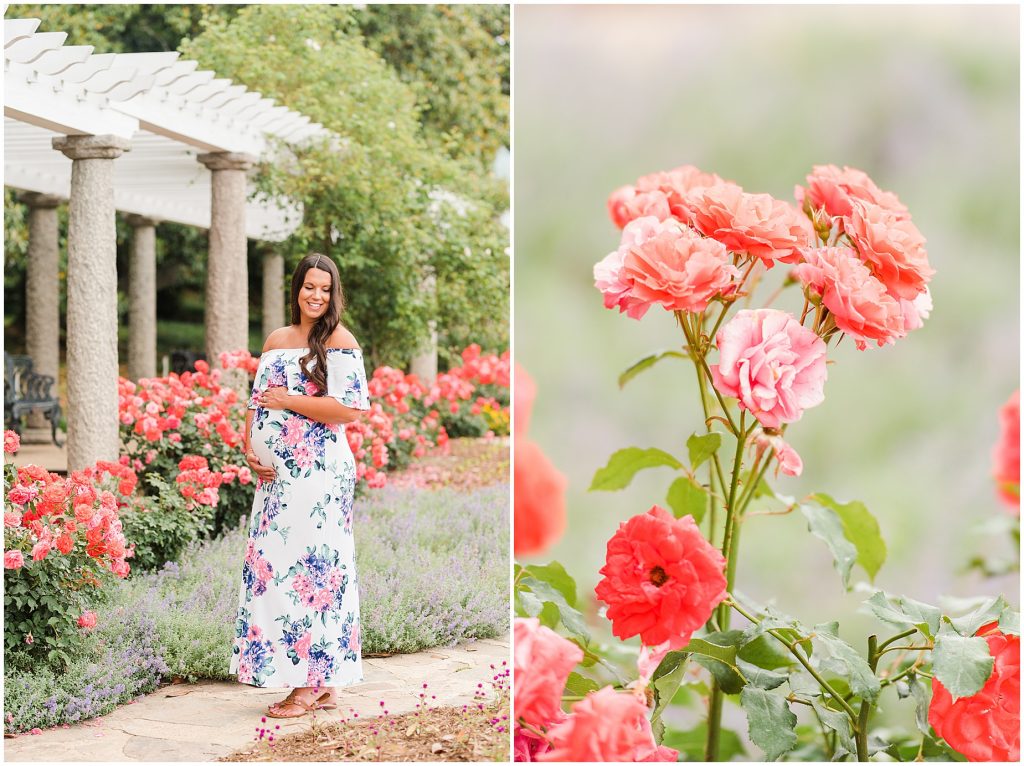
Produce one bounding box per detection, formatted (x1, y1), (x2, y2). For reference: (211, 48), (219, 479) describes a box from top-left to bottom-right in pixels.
(230, 253), (370, 718)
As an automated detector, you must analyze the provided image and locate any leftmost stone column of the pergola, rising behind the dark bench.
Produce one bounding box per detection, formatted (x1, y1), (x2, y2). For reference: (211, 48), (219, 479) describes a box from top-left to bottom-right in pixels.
(17, 192), (63, 430)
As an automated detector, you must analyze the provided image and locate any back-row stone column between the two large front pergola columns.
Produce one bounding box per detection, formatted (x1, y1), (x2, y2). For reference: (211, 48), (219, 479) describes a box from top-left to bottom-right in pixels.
(125, 214), (160, 380)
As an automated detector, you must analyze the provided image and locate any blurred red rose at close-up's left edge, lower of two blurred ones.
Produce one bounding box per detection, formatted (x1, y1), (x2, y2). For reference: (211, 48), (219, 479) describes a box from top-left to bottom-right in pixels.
(514, 436), (566, 556)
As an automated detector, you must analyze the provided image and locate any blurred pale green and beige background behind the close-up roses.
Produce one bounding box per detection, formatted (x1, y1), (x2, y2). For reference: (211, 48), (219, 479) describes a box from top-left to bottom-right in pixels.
(513, 5), (1020, 728)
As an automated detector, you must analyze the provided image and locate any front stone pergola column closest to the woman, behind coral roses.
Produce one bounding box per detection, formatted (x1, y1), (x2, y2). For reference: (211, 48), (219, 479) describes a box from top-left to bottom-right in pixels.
(197, 152), (256, 390)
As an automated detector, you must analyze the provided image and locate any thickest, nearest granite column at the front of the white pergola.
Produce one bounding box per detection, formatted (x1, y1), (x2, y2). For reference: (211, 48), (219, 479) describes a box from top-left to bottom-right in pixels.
(53, 135), (130, 471)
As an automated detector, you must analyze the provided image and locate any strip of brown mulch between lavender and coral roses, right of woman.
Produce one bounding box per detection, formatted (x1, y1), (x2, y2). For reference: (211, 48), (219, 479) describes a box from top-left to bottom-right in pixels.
(387, 436), (510, 490)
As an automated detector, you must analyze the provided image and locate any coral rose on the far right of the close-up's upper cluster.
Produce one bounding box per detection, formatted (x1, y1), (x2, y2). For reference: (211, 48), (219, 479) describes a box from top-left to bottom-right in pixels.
(843, 200), (935, 300)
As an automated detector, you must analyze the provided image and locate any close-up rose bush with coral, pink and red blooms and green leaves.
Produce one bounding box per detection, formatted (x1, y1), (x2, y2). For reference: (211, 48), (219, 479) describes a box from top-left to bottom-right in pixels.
(514, 166), (1020, 761)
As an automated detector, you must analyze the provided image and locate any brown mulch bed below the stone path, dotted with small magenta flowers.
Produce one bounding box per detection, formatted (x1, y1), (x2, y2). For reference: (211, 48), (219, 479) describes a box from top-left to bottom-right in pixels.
(218, 694), (510, 762)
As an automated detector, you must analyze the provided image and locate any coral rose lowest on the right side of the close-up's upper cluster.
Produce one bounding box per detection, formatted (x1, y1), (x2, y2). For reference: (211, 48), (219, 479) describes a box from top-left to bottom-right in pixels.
(793, 248), (906, 350)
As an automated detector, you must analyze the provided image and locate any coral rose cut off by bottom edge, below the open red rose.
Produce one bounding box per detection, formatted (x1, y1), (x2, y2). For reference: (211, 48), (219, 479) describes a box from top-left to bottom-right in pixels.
(536, 686), (679, 762)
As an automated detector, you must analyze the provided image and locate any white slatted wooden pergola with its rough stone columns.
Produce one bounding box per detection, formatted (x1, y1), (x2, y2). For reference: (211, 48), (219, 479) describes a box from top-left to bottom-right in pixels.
(4, 18), (333, 470)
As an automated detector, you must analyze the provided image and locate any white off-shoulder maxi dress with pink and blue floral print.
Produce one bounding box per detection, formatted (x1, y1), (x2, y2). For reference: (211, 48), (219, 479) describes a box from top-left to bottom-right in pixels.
(229, 348), (370, 687)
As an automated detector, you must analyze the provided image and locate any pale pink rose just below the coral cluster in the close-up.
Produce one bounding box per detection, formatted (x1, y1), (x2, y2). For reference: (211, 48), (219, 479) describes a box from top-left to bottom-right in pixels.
(711, 308), (827, 428)
